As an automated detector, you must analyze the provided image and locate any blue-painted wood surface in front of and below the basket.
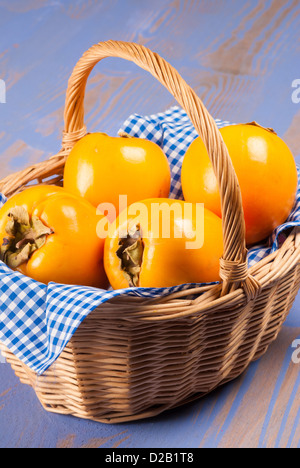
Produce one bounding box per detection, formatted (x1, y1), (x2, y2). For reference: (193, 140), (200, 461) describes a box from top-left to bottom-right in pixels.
(0, 322), (300, 448)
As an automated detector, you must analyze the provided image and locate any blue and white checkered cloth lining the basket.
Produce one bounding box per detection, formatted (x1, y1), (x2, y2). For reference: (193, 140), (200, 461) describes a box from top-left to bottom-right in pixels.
(0, 107), (300, 374)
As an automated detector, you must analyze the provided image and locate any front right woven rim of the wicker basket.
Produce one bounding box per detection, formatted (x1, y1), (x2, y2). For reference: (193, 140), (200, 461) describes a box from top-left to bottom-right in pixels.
(81, 228), (300, 326)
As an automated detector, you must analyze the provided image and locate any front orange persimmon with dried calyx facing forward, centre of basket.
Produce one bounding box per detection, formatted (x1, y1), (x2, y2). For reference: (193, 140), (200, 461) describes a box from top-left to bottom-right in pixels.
(104, 199), (223, 289)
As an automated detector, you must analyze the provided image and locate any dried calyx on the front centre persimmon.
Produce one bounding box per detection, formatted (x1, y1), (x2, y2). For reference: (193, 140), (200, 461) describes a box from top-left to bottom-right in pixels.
(116, 228), (144, 287)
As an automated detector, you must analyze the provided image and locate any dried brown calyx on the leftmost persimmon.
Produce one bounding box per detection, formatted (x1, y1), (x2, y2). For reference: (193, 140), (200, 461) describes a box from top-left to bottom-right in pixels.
(0, 206), (53, 269)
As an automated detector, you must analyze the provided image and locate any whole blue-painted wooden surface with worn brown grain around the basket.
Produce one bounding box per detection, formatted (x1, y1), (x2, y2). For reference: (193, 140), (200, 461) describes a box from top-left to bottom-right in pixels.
(0, 0), (300, 448)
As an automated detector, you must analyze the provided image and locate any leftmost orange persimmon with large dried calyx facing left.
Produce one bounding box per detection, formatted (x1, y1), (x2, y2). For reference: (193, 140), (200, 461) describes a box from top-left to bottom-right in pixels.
(0, 185), (108, 288)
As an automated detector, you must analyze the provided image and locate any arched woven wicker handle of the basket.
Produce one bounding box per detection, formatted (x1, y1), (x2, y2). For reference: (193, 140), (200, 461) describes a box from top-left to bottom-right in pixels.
(63, 41), (259, 299)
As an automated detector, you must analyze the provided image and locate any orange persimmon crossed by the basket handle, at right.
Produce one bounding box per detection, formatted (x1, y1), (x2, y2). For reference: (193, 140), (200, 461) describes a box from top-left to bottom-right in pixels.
(181, 122), (298, 245)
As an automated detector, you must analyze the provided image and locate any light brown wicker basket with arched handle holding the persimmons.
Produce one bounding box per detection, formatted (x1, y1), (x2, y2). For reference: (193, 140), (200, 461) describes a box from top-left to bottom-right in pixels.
(0, 41), (300, 423)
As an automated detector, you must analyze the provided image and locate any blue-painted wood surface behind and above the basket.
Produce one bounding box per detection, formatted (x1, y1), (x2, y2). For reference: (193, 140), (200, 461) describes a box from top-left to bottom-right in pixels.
(0, 0), (300, 179)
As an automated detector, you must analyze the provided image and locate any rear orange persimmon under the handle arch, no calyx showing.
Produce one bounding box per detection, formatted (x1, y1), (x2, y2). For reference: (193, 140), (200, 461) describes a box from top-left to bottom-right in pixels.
(64, 133), (171, 221)
